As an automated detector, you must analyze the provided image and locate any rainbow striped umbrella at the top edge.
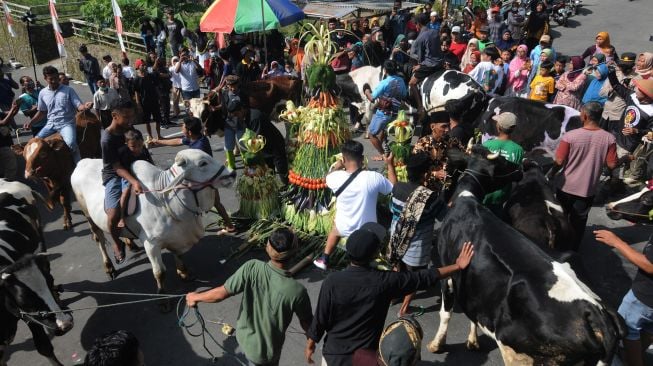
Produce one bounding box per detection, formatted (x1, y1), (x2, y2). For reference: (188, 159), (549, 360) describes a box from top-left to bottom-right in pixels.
(200, 0), (305, 33)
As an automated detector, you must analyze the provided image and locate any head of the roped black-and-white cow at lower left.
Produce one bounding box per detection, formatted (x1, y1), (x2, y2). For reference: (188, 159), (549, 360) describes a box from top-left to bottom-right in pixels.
(0, 254), (73, 335)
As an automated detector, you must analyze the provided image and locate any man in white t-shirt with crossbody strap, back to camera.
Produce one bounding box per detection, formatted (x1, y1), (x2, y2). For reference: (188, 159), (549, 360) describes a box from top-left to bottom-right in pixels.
(313, 140), (397, 269)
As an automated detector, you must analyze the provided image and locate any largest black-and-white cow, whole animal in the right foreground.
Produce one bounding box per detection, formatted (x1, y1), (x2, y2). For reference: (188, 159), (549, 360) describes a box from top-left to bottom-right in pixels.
(428, 147), (624, 365)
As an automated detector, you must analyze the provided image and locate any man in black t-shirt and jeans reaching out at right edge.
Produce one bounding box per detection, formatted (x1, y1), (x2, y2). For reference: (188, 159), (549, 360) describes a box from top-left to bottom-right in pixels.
(594, 230), (653, 366)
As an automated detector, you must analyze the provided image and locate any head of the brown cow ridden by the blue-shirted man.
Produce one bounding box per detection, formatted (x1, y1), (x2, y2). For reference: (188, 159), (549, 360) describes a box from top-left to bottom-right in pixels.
(23, 137), (73, 179)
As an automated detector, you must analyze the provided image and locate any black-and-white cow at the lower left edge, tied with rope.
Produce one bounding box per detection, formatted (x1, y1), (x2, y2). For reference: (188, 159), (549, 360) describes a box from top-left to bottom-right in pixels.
(0, 179), (73, 365)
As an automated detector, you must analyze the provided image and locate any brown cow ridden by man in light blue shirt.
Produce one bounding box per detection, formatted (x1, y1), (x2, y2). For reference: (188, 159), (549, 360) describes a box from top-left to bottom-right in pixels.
(13, 111), (102, 230)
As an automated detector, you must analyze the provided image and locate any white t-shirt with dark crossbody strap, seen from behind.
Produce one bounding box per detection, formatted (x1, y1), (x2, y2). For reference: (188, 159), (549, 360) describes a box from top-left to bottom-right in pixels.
(326, 170), (392, 237)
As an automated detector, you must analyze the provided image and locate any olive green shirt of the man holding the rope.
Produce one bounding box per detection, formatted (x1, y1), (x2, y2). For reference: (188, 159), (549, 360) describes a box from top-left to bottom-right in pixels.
(224, 259), (312, 363)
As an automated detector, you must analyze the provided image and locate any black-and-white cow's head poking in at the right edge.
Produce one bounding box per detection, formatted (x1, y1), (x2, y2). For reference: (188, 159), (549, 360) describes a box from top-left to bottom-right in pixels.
(606, 180), (653, 223)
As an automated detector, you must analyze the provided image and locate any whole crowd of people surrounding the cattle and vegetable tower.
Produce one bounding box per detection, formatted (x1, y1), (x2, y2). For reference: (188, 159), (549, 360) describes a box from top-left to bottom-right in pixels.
(0, 1), (653, 365)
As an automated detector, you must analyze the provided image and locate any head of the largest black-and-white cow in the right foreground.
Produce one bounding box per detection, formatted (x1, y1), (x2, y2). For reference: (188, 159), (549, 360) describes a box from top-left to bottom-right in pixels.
(454, 145), (523, 197)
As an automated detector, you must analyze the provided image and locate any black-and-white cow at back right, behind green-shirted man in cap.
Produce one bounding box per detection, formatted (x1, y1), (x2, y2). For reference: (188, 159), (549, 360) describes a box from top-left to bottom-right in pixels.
(474, 97), (583, 154)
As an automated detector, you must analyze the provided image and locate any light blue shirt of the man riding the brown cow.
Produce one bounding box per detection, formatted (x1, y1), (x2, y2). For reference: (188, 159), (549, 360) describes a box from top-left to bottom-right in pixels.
(37, 85), (83, 127)
